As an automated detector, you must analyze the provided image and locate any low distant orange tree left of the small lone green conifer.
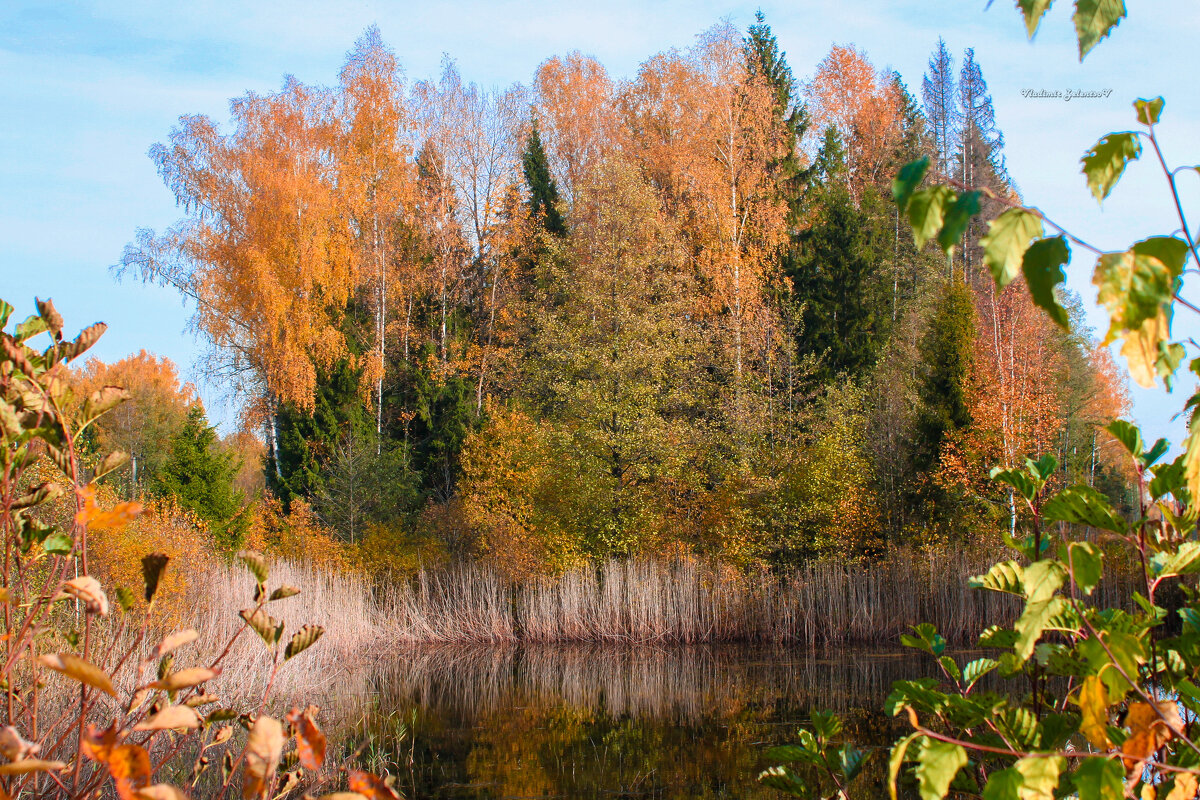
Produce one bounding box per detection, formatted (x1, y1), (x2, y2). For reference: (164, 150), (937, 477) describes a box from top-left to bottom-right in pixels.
(72, 350), (199, 498)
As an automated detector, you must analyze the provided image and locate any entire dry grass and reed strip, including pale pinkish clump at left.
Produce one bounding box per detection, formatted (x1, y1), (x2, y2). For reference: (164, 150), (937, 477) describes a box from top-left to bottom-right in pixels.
(136, 554), (1127, 703)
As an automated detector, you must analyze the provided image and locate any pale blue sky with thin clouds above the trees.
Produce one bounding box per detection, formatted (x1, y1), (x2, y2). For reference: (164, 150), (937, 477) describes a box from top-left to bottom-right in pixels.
(0, 0), (1200, 443)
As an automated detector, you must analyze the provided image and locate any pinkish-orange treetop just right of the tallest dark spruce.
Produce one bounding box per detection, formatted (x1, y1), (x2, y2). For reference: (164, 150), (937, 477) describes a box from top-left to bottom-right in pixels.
(804, 44), (901, 199)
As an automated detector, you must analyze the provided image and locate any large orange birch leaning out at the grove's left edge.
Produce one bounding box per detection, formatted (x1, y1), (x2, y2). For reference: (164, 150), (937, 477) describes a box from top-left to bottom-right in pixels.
(119, 79), (359, 453)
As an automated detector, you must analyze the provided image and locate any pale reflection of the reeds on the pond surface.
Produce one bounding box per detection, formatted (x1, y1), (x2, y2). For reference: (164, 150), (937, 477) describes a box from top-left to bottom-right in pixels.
(360, 645), (960, 722)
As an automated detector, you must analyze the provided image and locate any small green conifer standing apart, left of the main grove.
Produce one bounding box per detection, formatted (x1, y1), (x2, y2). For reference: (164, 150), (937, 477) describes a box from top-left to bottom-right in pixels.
(152, 405), (247, 549)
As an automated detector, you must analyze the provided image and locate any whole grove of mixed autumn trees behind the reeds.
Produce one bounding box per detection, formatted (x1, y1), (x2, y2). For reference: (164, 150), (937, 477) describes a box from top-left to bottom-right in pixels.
(105, 16), (1128, 575)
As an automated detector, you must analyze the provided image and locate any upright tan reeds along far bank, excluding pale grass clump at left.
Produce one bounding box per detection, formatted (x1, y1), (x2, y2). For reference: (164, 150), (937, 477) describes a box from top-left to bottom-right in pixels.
(384, 553), (1130, 645)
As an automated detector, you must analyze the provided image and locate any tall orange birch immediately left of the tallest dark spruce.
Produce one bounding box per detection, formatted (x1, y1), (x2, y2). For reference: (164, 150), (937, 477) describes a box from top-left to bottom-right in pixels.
(620, 23), (788, 417)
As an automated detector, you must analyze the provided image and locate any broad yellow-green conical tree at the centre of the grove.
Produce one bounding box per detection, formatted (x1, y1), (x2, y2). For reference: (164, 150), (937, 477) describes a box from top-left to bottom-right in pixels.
(524, 161), (704, 554)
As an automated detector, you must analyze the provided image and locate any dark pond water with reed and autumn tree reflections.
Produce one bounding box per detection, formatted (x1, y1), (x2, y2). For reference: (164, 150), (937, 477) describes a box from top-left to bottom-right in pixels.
(340, 645), (935, 800)
